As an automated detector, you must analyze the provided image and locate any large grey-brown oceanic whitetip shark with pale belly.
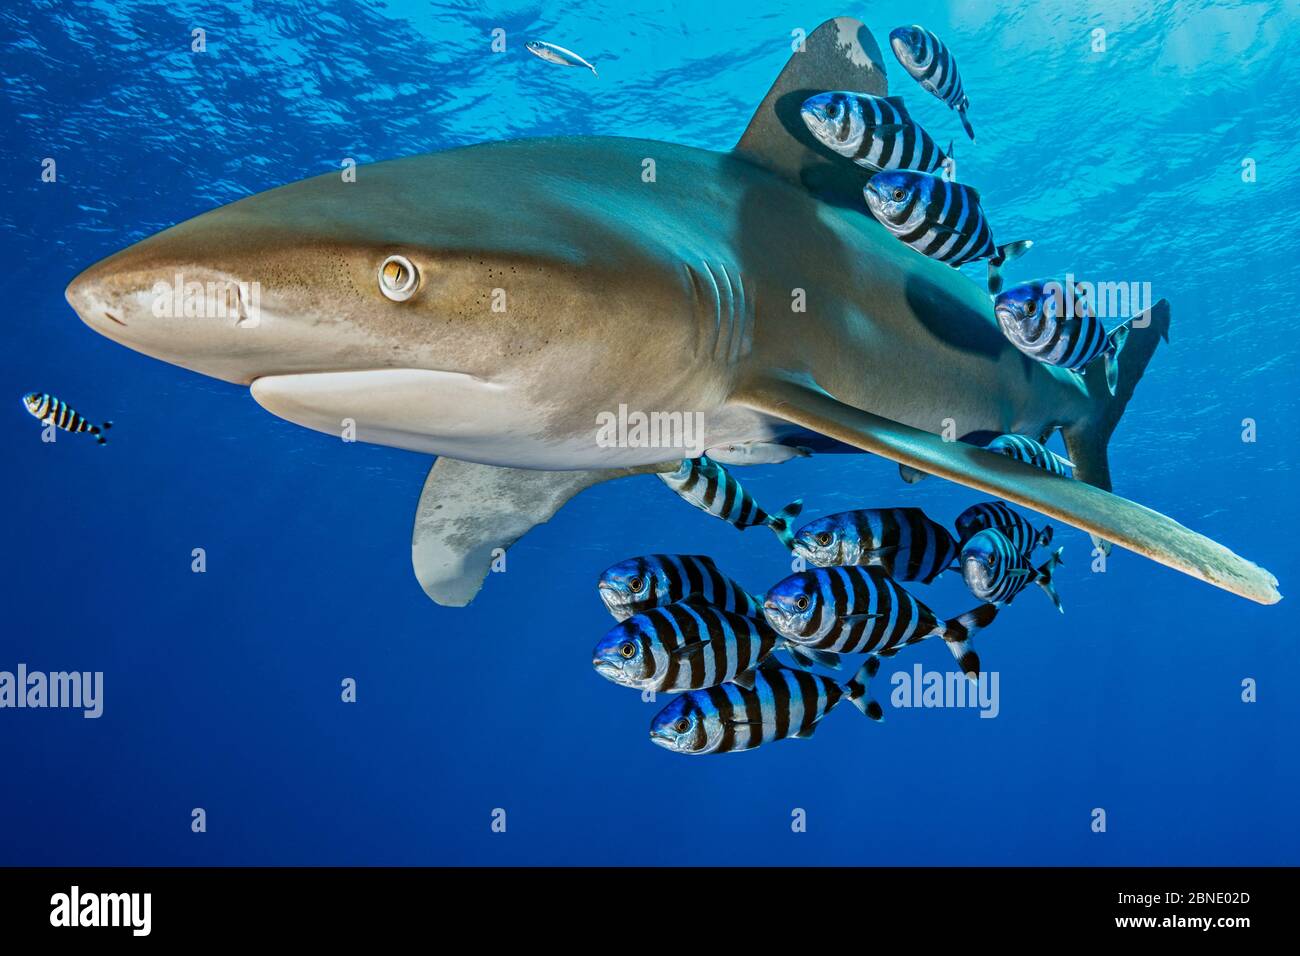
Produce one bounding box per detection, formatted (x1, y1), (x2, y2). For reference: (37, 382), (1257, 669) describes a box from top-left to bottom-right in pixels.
(68, 18), (1281, 605)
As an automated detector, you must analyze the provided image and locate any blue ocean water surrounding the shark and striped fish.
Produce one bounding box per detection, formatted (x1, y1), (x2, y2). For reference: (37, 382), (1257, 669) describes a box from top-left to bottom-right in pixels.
(0, 0), (1300, 865)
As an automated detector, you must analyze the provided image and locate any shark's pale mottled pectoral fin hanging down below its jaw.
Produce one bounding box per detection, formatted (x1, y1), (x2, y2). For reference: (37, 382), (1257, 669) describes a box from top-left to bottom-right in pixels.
(411, 458), (665, 607)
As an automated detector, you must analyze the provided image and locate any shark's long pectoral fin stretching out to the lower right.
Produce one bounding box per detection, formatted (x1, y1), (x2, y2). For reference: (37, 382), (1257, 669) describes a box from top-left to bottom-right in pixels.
(733, 377), (1282, 604)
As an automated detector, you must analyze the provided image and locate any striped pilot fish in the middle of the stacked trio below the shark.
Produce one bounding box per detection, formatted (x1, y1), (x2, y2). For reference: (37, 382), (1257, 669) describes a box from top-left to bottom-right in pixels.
(592, 604), (785, 691)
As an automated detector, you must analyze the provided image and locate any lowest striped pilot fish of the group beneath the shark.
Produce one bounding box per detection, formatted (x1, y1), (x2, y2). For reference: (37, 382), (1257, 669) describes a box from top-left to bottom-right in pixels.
(650, 657), (884, 754)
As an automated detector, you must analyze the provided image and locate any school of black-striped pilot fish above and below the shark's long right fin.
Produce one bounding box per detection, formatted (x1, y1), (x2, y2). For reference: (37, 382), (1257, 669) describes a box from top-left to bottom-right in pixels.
(592, 20), (1128, 754)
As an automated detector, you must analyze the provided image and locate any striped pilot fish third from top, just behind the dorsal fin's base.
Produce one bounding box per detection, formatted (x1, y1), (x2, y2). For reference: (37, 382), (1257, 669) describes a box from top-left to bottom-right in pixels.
(862, 169), (1034, 293)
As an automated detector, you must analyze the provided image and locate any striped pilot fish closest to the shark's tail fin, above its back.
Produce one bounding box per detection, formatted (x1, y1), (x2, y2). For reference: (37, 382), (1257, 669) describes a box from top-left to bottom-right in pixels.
(993, 280), (1128, 395)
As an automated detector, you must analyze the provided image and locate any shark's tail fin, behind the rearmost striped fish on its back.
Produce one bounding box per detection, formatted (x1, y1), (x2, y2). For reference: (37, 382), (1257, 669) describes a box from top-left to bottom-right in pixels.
(1063, 299), (1169, 492)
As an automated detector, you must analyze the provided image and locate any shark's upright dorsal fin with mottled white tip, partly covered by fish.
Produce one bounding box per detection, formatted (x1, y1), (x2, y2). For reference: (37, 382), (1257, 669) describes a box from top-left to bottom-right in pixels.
(736, 17), (889, 206)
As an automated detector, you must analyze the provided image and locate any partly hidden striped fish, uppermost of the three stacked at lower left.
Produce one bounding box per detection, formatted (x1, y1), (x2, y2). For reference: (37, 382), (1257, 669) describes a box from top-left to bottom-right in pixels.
(597, 554), (763, 620)
